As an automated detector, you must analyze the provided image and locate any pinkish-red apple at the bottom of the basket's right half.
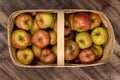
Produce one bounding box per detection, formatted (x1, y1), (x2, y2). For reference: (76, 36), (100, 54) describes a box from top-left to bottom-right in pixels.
(79, 49), (95, 64)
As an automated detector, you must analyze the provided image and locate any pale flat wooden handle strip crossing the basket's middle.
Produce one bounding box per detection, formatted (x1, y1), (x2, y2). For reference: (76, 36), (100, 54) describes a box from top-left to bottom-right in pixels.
(57, 11), (64, 66)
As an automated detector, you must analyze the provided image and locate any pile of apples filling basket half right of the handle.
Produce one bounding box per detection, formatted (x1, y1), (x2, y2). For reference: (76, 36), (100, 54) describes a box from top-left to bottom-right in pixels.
(64, 12), (108, 64)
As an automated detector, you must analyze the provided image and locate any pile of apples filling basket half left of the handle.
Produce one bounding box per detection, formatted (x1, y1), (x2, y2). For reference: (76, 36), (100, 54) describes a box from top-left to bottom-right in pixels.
(11, 12), (57, 65)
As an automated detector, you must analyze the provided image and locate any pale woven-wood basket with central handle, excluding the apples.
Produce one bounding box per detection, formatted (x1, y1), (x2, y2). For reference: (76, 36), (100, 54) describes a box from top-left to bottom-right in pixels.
(8, 9), (115, 68)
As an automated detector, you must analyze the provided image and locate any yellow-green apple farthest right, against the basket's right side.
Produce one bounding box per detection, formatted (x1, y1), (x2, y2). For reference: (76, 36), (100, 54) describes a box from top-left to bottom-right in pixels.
(91, 27), (108, 45)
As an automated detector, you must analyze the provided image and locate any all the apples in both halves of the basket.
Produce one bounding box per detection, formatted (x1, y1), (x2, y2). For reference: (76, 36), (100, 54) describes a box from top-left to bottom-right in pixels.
(11, 12), (108, 65)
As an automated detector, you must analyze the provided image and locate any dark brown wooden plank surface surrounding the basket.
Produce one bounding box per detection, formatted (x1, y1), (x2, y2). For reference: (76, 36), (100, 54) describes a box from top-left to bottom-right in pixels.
(0, 0), (120, 80)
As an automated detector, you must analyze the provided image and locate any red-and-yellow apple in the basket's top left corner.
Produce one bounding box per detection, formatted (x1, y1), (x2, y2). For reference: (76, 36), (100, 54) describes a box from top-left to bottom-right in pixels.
(15, 13), (33, 30)
